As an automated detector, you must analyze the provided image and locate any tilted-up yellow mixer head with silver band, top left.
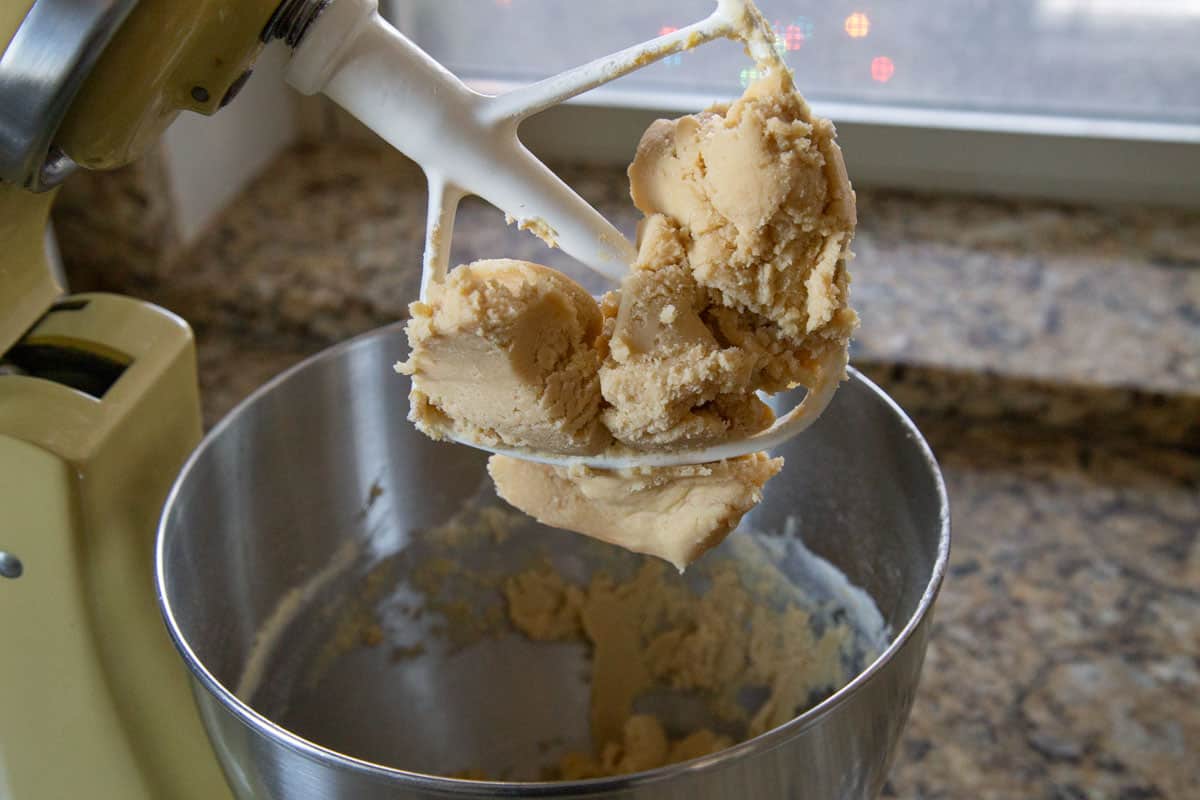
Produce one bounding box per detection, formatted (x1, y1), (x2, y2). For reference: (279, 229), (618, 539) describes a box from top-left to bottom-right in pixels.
(0, 0), (326, 355)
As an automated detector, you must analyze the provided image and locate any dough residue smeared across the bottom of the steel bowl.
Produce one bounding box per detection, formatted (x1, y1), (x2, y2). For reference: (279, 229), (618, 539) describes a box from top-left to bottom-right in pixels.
(267, 501), (873, 780)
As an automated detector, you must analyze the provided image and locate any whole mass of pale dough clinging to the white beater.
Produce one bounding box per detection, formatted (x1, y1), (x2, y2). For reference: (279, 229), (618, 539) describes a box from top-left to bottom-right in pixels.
(397, 70), (857, 570)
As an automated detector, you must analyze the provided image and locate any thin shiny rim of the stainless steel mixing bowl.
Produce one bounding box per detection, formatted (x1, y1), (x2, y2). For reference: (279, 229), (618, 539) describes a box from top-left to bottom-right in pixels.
(154, 320), (950, 798)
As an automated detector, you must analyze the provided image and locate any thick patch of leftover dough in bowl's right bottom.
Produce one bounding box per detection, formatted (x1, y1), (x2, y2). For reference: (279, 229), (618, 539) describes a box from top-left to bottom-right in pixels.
(504, 559), (852, 780)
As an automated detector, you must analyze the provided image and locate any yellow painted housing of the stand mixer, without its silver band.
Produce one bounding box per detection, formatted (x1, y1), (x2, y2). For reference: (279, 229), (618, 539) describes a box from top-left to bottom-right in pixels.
(0, 0), (296, 800)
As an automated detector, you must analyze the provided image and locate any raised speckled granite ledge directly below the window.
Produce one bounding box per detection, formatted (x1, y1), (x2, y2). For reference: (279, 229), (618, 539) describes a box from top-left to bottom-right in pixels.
(60, 142), (1200, 392)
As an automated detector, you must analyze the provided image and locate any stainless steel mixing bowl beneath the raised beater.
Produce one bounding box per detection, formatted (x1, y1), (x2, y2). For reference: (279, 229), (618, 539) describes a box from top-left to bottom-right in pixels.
(157, 325), (949, 800)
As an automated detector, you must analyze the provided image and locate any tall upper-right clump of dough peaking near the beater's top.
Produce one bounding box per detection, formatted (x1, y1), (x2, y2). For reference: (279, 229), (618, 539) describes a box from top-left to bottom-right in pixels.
(629, 70), (857, 340)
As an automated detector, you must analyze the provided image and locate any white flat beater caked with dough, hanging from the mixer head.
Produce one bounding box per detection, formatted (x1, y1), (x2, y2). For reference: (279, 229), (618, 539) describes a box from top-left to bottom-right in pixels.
(286, 0), (846, 469)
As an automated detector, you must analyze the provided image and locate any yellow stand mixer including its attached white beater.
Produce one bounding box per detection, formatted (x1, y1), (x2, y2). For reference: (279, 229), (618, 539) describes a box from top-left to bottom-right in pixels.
(7, 0), (845, 800)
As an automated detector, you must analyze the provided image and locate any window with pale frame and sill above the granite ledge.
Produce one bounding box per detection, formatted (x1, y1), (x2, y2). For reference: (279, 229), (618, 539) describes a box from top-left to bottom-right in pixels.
(385, 0), (1200, 203)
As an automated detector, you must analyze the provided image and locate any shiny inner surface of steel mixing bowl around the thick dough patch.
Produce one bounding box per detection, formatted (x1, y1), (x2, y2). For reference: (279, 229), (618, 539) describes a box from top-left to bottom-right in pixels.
(160, 327), (943, 780)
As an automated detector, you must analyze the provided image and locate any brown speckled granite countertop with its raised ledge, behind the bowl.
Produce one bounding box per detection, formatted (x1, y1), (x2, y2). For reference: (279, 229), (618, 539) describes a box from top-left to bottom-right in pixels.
(60, 143), (1200, 800)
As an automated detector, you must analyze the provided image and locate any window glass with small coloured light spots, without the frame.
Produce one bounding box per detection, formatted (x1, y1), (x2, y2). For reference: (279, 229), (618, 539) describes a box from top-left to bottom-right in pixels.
(398, 0), (1200, 125)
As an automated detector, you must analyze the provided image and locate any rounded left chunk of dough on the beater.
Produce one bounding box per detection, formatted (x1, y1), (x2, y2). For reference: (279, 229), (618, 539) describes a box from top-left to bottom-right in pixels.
(396, 259), (608, 453)
